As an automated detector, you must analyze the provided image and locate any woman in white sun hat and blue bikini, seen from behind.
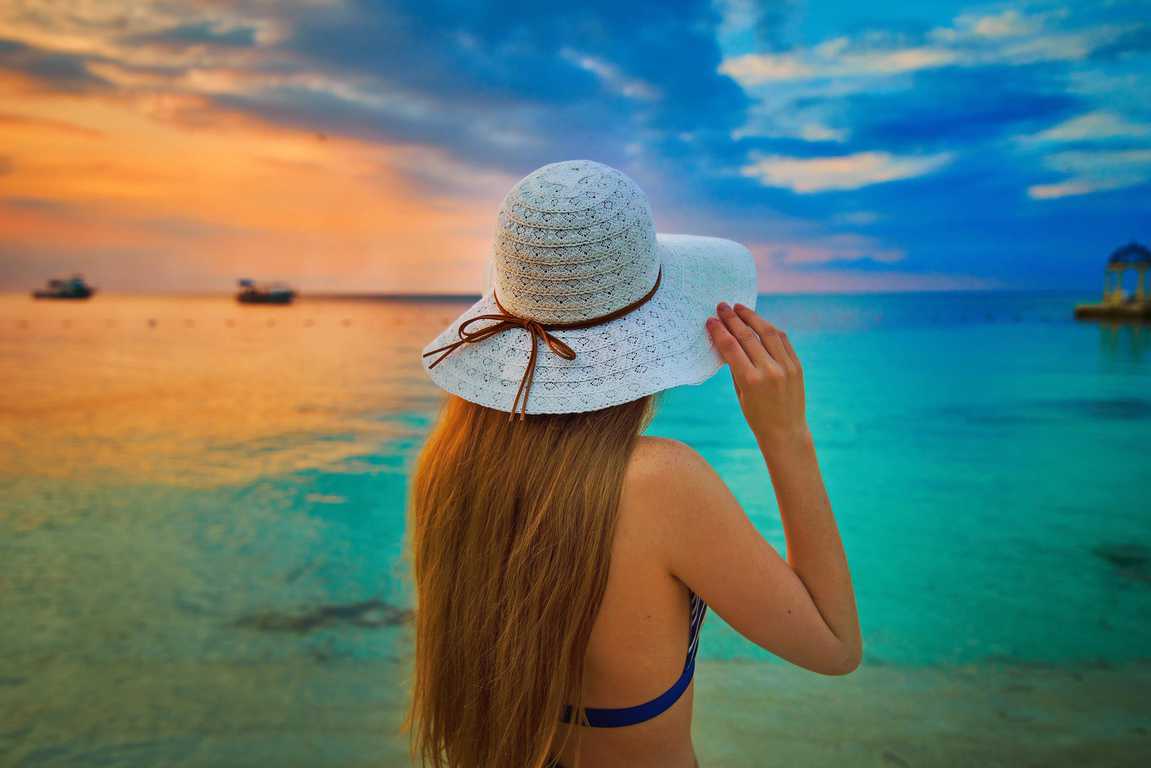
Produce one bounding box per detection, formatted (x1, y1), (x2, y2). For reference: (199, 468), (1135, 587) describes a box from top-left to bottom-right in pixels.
(405, 160), (862, 768)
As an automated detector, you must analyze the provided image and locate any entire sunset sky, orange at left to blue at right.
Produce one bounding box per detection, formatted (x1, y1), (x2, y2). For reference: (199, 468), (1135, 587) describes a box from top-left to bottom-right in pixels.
(0, 0), (1151, 294)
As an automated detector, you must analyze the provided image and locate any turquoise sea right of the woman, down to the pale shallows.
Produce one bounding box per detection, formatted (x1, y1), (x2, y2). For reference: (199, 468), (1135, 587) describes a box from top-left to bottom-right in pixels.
(672, 294), (1151, 664)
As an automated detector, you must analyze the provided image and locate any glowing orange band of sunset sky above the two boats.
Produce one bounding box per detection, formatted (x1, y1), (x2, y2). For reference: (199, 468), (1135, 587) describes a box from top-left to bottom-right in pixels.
(0, 77), (514, 291)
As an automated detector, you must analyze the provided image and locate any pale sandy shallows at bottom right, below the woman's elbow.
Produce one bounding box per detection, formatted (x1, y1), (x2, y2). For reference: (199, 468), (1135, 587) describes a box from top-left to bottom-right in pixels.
(693, 662), (1151, 768)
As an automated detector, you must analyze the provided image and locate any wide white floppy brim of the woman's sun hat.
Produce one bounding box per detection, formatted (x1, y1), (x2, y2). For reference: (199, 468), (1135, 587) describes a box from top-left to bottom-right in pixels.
(422, 233), (756, 415)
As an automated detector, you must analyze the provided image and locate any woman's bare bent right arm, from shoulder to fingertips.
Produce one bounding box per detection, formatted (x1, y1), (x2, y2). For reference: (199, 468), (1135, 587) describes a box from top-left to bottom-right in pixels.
(638, 305), (862, 675)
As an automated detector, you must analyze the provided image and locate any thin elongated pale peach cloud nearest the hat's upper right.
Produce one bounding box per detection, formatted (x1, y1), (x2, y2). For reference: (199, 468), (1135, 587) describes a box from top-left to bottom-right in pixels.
(740, 152), (951, 193)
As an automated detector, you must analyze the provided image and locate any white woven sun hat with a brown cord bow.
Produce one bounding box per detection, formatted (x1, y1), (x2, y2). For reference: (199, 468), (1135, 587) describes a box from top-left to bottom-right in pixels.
(424, 160), (756, 418)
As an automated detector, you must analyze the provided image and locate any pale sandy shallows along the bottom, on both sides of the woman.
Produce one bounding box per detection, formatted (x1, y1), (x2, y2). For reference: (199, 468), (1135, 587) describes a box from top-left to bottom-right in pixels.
(0, 661), (1151, 768)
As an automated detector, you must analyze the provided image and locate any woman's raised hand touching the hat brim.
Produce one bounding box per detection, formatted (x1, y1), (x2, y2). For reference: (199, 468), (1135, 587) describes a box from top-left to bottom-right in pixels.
(707, 303), (810, 449)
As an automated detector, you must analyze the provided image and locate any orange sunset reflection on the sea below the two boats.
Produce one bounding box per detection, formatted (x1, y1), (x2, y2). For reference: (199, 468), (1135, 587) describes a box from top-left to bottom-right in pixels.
(0, 297), (462, 488)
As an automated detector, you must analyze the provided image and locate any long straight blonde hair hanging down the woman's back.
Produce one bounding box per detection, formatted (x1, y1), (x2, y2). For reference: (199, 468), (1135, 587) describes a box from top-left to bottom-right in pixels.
(404, 395), (654, 768)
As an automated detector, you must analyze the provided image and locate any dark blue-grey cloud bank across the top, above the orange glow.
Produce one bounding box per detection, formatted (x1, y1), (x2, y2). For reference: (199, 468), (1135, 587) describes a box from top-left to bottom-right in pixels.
(0, 0), (748, 188)
